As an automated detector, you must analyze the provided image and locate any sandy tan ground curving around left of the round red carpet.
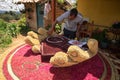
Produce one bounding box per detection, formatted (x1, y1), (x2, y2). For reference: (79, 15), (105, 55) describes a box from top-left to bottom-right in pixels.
(0, 35), (119, 80)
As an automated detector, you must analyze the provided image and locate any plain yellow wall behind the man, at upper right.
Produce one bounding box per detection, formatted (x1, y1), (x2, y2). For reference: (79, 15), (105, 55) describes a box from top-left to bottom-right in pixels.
(77, 0), (120, 26)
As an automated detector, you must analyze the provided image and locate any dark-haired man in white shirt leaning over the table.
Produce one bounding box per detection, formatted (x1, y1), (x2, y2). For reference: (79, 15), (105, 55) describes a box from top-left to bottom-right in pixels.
(48, 8), (83, 39)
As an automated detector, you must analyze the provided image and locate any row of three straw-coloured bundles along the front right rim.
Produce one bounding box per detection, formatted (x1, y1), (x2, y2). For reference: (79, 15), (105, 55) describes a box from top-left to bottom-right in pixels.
(50, 39), (98, 67)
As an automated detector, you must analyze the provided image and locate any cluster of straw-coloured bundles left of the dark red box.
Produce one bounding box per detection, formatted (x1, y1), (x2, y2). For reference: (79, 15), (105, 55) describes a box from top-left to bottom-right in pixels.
(25, 28), (55, 53)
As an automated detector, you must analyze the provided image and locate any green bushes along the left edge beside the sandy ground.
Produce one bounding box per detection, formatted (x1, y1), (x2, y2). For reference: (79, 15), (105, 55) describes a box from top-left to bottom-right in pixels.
(0, 12), (28, 48)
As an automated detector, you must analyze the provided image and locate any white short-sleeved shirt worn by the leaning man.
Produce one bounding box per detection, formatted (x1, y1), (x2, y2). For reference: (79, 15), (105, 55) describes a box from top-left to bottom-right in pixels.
(56, 11), (83, 31)
